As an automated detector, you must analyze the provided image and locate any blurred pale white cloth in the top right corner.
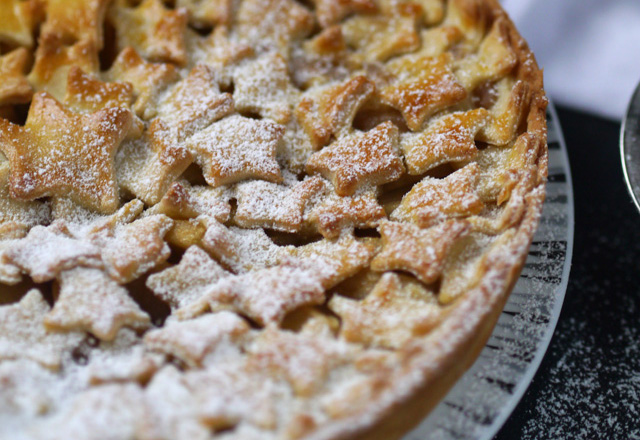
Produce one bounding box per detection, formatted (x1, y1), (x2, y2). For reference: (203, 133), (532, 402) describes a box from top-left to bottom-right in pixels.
(502, 0), (640, 120)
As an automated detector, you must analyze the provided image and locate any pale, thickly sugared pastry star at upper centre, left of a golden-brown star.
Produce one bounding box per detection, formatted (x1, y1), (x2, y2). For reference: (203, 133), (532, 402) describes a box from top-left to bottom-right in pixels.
(233, 52), (298, 124)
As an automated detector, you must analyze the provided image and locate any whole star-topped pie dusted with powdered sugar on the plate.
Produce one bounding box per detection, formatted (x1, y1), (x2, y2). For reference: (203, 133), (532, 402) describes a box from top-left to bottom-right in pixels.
(0, 0), (547, 440)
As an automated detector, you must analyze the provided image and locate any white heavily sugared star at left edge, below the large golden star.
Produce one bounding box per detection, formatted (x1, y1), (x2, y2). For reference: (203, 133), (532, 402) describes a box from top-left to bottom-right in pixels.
(4, 222), (102, 283)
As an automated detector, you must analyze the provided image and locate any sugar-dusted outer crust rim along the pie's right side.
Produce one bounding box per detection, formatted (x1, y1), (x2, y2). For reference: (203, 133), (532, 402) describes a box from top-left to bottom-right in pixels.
(310, 0), (548, 440)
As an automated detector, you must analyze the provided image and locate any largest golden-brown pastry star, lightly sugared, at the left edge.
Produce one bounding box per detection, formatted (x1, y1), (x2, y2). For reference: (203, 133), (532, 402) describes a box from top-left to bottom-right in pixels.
(0, 93), (132, 213)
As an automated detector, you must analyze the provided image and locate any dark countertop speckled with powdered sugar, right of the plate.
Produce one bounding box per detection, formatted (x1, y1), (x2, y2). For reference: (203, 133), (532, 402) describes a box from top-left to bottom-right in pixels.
(494, 107), (640, 440)
